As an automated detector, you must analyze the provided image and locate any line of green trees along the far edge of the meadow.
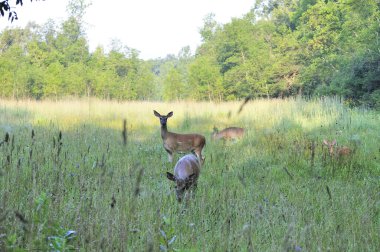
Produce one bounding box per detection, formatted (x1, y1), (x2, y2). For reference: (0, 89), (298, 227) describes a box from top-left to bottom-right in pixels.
(0, 0), (380, 108)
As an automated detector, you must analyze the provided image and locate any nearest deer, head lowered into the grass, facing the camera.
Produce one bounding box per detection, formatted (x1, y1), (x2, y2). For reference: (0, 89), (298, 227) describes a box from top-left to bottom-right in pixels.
(166, 154), (201, 202)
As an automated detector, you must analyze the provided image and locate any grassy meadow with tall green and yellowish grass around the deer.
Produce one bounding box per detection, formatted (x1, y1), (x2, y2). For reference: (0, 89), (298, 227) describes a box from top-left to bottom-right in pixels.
(0, 99), (380, 251)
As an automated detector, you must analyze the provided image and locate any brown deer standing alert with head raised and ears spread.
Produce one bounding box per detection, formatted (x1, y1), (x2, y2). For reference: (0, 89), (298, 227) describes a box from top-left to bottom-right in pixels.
(153, 110), (206, 164)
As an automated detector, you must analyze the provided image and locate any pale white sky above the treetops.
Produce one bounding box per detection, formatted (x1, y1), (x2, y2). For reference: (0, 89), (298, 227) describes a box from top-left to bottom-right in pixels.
(0, 0), (255, 60)
